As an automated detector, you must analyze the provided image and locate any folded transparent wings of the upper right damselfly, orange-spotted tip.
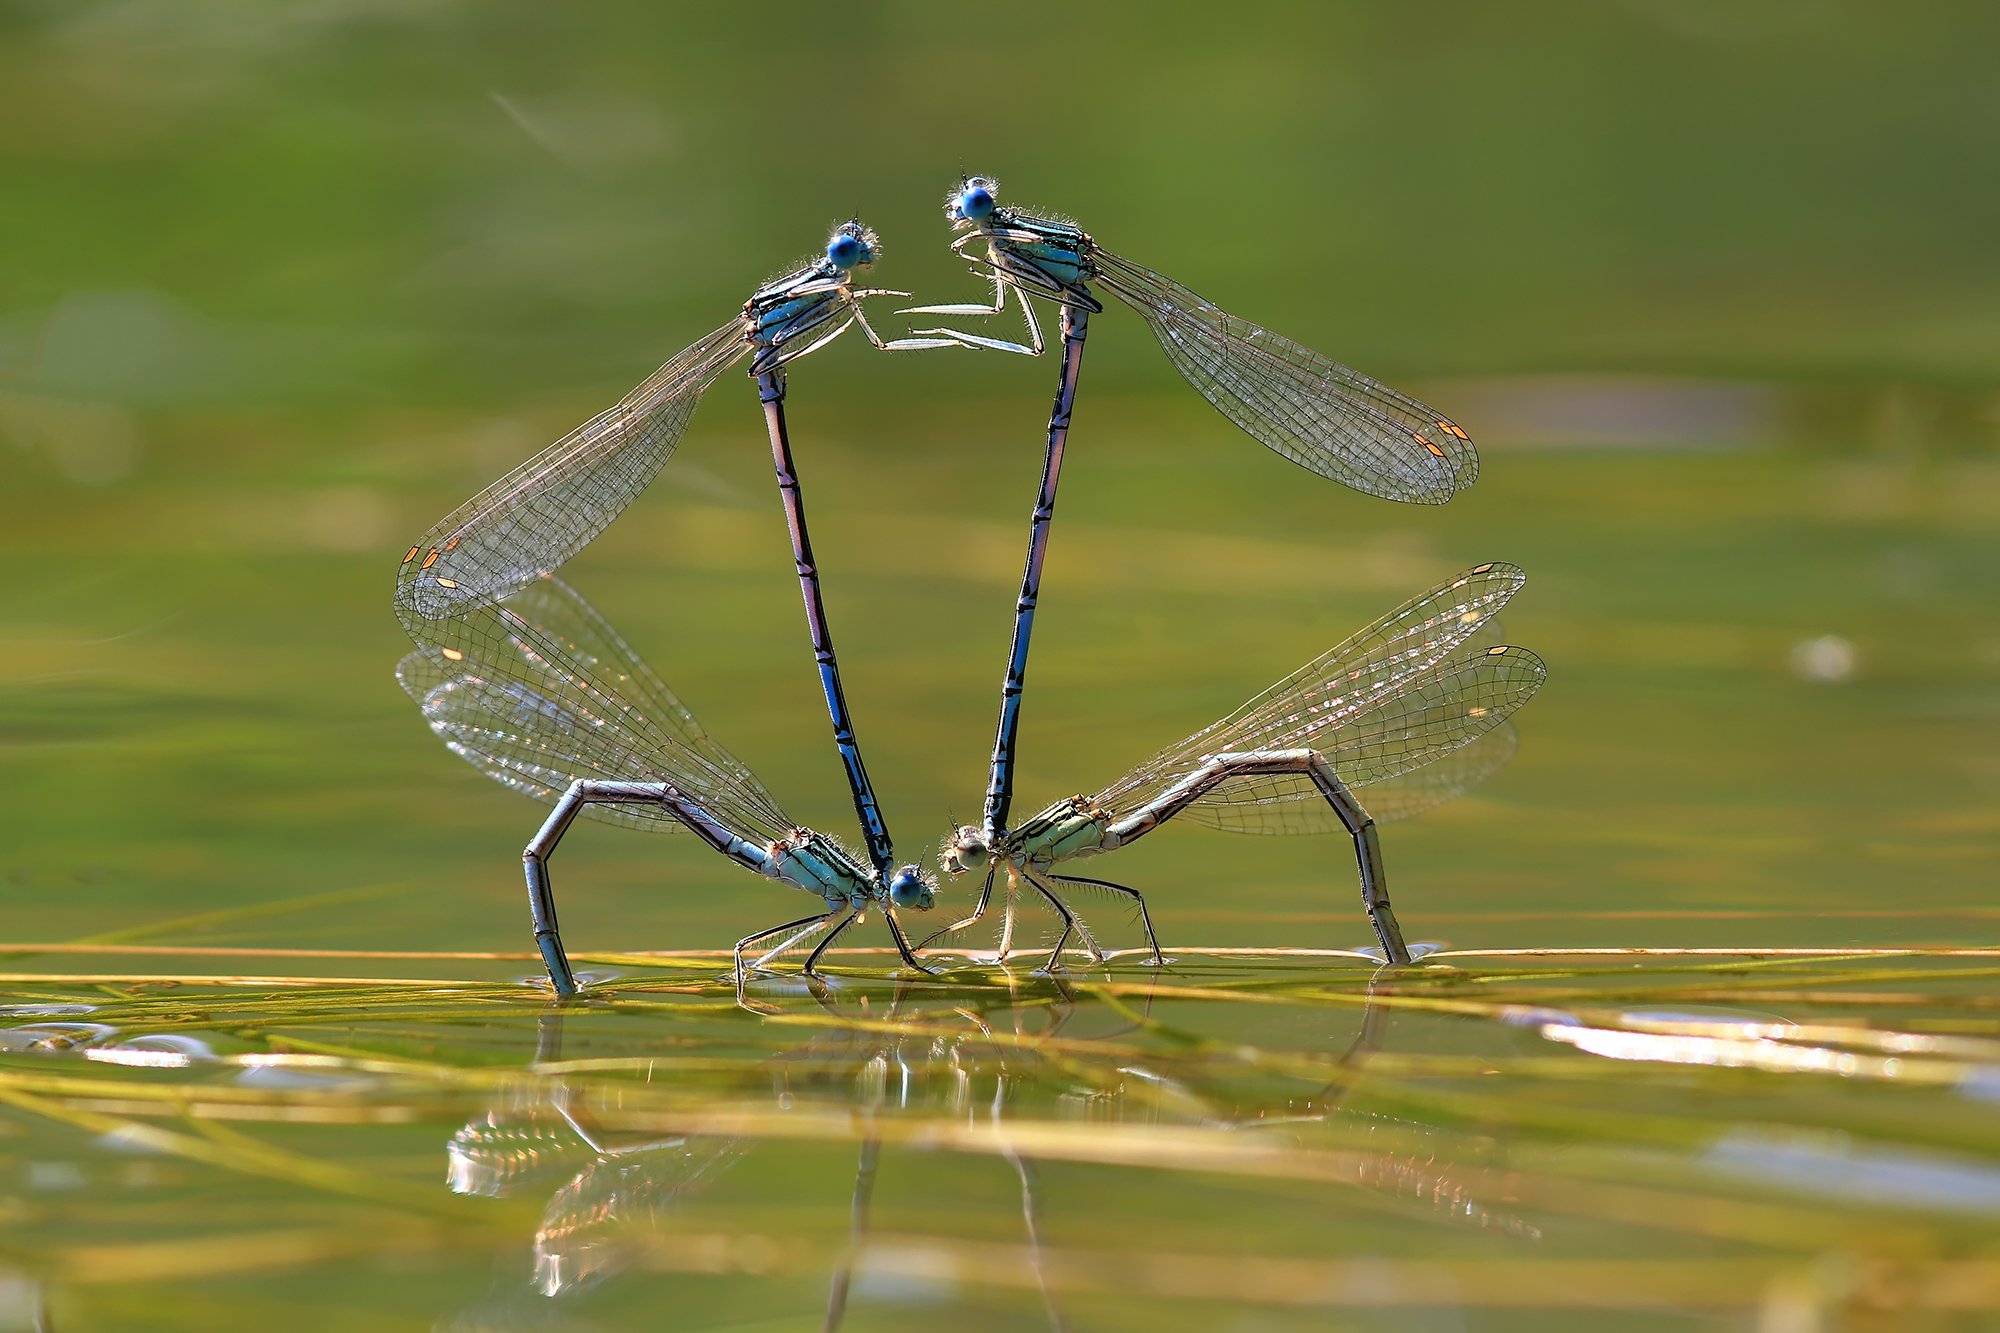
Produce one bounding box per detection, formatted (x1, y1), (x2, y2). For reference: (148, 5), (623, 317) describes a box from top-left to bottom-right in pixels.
(1094, 250), (1480, 504)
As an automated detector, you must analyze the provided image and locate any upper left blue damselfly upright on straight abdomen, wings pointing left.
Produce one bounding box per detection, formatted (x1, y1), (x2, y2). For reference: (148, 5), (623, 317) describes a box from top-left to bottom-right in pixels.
(396, 220), (952, 879)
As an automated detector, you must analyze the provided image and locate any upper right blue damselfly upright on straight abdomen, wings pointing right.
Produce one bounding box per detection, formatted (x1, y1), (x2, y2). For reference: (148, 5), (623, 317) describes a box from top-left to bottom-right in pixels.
(908, 176), (1480, 839)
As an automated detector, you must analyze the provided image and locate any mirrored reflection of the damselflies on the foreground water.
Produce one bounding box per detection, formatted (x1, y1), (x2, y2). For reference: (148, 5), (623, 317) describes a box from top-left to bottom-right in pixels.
(446, 979), (1540, 1329)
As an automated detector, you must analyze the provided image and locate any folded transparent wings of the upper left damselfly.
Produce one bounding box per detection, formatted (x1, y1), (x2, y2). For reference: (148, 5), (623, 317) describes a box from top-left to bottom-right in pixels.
(396, 320), (750, 626)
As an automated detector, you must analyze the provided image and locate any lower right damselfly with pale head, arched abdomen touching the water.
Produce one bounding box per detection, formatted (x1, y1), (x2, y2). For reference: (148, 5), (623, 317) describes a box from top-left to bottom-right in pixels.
(924, 564), (1546, 969)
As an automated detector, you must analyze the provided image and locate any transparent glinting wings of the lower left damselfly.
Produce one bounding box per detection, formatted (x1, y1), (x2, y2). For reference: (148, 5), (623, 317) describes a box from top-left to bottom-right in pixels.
(396, 574), (792, 841)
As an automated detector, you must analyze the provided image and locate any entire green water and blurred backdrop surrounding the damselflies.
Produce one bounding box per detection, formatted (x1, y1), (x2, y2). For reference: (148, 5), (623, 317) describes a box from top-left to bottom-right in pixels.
(0, 0), (2000, 1333)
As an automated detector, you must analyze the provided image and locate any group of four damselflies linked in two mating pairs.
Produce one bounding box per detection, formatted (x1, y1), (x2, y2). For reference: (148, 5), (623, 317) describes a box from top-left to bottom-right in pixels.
(396, 178), (1544, 993)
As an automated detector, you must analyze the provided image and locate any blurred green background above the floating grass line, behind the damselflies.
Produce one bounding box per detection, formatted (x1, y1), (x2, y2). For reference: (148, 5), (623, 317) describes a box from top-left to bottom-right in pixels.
(0, 0), (2000, 953)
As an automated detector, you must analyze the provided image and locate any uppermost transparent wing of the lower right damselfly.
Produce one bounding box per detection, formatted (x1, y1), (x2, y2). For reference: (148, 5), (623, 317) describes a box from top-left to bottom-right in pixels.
(1096, 560), (1528, 811)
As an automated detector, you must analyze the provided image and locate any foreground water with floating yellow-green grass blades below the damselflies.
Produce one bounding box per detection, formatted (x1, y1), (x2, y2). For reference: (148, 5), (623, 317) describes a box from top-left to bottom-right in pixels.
(11, 951), (2000, 1329)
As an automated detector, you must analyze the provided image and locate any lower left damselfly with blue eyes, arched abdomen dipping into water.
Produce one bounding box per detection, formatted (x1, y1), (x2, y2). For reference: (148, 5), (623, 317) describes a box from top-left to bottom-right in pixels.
(396, 574), (936, 995)
